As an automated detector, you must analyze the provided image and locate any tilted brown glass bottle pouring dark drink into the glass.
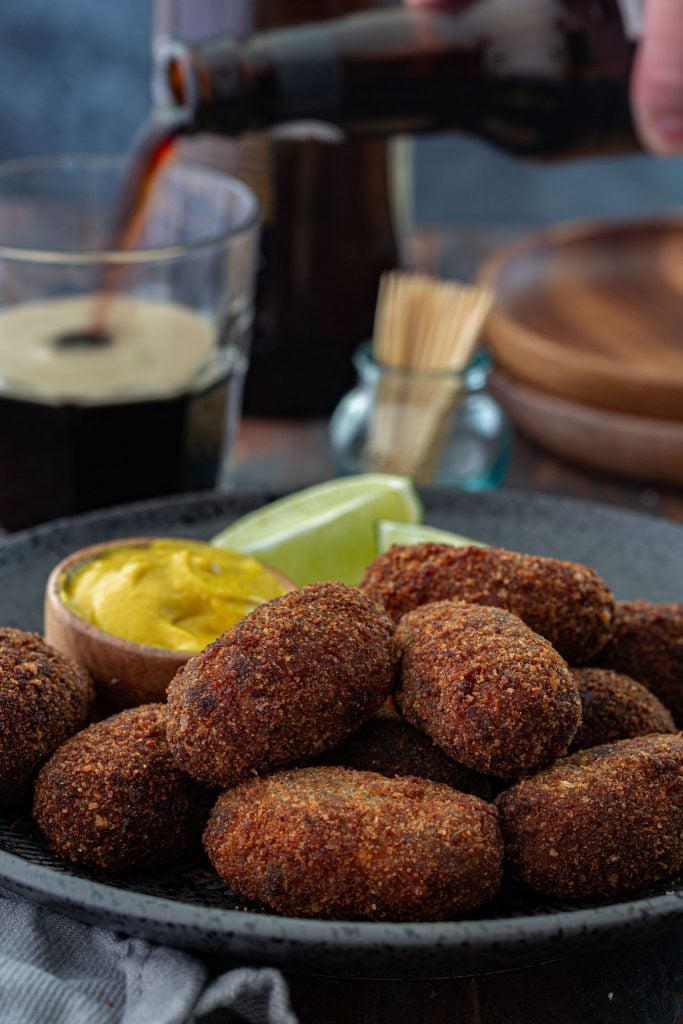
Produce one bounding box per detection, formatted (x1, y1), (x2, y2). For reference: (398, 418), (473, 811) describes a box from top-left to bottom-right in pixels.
(166, 0), (637, 158)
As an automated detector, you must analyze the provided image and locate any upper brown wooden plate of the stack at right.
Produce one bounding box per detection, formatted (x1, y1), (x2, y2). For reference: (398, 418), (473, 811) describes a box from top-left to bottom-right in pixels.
(481, 218), (683, 420)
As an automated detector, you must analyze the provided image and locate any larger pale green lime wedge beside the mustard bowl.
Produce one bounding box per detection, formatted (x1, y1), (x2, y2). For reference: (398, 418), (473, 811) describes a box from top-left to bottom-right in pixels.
(211, 473), (422, 587)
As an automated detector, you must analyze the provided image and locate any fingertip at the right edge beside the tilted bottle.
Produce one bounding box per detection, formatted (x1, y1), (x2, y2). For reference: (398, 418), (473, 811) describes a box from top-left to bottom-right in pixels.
(631, 0), (683, 155)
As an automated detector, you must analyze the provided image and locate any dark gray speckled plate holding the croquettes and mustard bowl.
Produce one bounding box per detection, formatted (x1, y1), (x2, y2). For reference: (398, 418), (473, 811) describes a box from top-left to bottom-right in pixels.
(0, 492), (683, 978)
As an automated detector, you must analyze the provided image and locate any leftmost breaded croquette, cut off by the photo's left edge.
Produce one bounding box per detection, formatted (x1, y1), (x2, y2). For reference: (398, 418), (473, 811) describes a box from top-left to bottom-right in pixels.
(0, 627), (94, 807)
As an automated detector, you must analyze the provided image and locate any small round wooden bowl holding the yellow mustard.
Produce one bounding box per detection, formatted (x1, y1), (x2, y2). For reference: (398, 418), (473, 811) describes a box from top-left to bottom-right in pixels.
(44, 537), (295, 709)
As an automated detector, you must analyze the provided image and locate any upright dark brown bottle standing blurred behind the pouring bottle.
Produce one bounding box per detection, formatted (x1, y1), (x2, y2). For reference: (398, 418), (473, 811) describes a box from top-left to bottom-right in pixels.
(160, 0), (396, 416)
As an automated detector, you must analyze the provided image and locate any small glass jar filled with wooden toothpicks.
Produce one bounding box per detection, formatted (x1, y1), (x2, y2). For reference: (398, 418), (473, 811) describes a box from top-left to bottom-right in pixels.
(330, 271), (510, 490)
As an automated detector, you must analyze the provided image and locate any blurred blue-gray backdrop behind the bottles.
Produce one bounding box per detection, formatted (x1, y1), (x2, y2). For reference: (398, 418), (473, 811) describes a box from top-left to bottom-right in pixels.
(0, 0), (683, 225)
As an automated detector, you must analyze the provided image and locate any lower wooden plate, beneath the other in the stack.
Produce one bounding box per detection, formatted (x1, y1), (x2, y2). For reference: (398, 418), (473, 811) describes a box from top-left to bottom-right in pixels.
(490, 369), (683, 485)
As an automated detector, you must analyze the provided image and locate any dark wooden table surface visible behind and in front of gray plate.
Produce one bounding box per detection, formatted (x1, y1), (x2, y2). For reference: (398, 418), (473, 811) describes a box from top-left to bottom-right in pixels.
(225, 418), (683, 1024)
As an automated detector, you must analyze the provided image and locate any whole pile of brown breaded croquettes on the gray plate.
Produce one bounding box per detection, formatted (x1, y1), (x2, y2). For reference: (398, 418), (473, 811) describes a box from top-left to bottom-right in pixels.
(0, 544), (683, 922)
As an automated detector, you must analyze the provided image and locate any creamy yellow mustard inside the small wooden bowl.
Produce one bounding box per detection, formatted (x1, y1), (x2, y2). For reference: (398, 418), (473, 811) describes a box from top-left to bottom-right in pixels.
(60, 539), (288, 651)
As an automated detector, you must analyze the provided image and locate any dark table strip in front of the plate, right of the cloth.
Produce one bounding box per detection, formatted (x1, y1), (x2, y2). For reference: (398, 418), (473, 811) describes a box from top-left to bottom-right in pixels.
(287, 934), (683, 1024)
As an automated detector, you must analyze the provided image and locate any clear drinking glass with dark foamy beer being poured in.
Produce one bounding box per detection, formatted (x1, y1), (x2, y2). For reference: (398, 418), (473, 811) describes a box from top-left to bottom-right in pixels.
(0, 157), (259, 529)
